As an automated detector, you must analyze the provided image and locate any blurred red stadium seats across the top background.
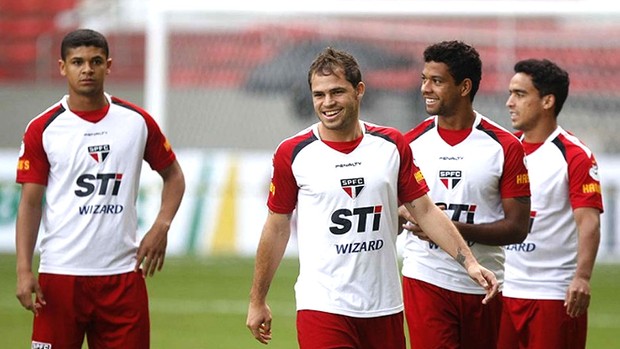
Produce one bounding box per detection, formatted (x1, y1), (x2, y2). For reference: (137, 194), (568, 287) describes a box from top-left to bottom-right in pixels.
(0, 9), (620, 97)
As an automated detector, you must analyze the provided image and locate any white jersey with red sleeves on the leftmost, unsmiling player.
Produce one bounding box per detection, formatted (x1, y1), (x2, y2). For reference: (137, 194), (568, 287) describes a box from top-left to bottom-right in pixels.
(17, 95), (175, 275)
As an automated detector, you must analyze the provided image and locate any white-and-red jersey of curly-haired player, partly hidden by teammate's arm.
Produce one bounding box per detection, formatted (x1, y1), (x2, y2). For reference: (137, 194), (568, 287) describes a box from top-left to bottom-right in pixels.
(402, 113), (530, 294)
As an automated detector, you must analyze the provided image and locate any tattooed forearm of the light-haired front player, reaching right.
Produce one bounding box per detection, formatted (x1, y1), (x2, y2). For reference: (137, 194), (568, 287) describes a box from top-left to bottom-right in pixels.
(404, 195), (499, 304)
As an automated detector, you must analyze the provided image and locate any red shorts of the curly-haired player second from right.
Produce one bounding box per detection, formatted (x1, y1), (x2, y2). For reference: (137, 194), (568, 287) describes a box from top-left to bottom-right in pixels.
(403, 277), (502, 349)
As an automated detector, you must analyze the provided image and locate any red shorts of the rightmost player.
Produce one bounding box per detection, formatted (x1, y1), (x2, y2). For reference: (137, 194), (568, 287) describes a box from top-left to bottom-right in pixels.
(497, 297), (588, 349)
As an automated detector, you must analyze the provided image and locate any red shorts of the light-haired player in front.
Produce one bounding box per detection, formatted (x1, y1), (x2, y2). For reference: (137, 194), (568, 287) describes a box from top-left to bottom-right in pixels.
(297, 310), (406, 349)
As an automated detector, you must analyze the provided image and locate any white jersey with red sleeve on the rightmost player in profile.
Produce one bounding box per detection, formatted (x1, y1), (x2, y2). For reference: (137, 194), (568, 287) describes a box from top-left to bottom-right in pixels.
(504, 127), (603, 300)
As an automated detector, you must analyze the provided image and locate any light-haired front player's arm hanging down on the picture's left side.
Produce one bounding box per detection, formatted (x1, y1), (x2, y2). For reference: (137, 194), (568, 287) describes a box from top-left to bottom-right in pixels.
(246, 210), (291, 344)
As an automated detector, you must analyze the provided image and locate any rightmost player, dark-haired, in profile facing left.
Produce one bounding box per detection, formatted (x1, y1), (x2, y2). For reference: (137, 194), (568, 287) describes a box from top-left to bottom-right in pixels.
(498, 59), (603, 349)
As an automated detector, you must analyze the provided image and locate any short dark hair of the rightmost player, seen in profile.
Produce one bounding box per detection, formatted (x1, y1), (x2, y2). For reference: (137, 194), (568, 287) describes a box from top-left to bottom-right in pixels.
(514, 58), (570, 117)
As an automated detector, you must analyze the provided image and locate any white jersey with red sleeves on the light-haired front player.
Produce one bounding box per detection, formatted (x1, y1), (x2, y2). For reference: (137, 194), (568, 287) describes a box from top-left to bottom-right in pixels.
(268, 123), (428, 318)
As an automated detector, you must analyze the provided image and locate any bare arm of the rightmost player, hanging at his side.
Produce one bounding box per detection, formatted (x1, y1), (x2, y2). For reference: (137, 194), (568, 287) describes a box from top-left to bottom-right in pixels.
(564, 207), (601, 317)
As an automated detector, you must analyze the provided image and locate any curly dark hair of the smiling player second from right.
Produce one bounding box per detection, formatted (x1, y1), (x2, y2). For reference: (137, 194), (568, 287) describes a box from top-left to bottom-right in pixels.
(424, 40), (482, 101)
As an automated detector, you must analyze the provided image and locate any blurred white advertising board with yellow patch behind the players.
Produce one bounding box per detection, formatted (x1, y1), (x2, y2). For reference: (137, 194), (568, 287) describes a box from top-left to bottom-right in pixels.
(0, 149), (620, 261)
